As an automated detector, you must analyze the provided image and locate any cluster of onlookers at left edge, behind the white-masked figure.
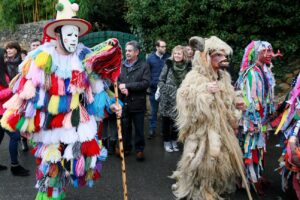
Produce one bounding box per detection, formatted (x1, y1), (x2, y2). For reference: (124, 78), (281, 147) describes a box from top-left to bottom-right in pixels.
(0, 39), (41, 176)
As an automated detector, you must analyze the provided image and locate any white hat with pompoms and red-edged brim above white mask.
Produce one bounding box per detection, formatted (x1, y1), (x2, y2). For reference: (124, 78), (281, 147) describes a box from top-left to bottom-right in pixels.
(44, 0), (92, 39)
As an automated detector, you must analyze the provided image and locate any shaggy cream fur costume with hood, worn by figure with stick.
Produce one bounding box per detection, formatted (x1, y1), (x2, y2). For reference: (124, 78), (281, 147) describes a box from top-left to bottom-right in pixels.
(171, 37), (242, 200)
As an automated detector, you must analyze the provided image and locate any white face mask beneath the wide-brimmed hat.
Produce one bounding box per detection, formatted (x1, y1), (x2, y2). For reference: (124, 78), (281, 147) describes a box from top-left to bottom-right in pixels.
(61, 25), (79, 53)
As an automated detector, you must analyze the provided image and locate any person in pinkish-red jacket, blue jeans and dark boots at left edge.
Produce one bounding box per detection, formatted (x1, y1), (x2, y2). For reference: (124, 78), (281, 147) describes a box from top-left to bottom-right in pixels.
(0, 47), (29, 176)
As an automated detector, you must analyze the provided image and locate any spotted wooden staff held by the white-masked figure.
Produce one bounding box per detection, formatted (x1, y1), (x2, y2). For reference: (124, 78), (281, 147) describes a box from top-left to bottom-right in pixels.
(114, 82), (128, 200)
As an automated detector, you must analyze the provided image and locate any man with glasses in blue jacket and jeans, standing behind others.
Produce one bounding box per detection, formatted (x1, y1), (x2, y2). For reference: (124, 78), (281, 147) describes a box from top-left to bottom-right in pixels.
(147, 40), (170, 139)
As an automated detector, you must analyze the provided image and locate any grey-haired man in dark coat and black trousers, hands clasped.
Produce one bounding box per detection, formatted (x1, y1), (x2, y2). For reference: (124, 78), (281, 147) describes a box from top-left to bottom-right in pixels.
(119, 41), (150, 161)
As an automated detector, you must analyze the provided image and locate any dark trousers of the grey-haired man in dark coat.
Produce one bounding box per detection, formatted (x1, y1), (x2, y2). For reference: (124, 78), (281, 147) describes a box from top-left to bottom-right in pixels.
(122, 111), (145, 152)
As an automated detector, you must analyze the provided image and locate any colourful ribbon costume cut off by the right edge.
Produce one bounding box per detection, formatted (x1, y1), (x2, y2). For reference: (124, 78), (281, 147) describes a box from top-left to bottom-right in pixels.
(276, 75), (300, 199)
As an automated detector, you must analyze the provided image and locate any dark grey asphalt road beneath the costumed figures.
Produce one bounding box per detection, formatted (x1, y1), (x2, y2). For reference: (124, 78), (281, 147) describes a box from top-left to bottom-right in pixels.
(0, 124), (294, 200)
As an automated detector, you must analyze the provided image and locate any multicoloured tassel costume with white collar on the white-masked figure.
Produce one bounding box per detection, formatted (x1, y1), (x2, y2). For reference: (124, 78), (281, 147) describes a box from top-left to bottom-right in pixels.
(1, 43), (119, 200)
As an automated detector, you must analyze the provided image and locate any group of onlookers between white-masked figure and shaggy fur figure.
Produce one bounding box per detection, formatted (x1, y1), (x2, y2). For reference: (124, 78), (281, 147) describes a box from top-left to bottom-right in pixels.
(109, 40), (194, 161)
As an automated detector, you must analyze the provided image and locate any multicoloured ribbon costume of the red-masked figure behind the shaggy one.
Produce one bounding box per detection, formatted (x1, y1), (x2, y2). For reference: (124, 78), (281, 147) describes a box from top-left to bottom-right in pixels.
(236, 41), (275, 183)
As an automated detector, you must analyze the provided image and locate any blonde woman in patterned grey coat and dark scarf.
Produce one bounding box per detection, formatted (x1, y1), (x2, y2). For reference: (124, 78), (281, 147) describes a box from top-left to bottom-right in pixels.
(158, 45), (192, 152)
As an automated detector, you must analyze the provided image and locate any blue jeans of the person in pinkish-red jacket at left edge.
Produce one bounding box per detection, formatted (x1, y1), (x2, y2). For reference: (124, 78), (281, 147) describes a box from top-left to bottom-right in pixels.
(6, 132), (21, 165)
